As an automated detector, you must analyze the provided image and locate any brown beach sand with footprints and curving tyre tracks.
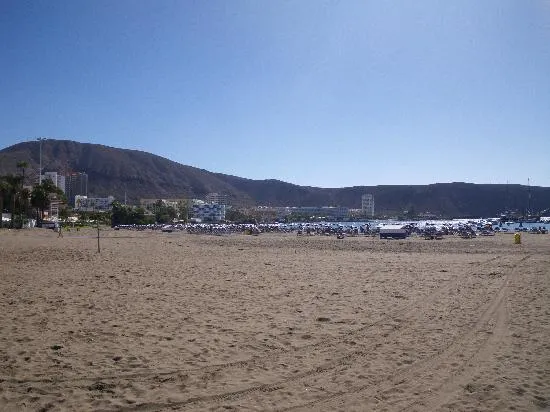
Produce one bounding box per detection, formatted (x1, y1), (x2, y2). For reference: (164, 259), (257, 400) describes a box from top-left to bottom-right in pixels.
(0, 229), (550, 411)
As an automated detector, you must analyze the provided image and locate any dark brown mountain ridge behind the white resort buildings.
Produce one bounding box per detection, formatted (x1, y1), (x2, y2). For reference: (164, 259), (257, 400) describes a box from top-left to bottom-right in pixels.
(0, 139), (550, 217)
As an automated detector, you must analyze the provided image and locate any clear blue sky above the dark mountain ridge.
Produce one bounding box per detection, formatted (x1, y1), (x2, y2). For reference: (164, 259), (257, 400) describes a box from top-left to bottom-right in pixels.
(0, 0), (550, 187)
